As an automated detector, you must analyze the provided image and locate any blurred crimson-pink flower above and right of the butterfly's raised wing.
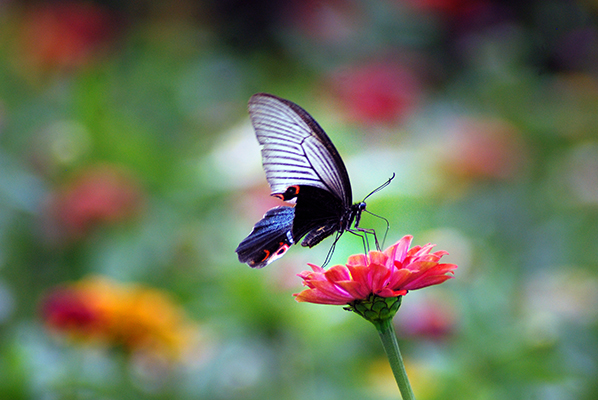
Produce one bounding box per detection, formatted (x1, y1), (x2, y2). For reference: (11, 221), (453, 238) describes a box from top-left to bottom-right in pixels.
(332, 62), (421, 124)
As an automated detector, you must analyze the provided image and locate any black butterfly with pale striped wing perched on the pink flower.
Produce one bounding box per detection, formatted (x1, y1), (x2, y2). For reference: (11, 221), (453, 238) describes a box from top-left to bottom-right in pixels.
(235, 93), (392, 268)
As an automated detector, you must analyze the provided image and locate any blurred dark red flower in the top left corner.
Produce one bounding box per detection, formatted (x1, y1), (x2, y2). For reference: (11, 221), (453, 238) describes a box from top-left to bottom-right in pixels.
(18, 1), (117, 69)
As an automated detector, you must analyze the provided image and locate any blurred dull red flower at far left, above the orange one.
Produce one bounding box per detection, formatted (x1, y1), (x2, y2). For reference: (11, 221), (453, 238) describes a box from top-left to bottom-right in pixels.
(47, 166), (143, 238)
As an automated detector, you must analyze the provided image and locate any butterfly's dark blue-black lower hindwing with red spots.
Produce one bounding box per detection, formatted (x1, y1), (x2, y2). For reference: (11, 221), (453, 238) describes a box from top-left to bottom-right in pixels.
(235, 206), (295, 268)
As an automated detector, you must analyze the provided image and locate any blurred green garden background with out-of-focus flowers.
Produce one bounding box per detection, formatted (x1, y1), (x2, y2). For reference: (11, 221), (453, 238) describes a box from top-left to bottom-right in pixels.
(0, 0), (598, 400)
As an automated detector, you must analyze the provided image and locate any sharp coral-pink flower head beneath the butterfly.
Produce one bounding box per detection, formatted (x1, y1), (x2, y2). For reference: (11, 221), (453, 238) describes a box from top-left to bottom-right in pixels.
(295, 235), (457, 305)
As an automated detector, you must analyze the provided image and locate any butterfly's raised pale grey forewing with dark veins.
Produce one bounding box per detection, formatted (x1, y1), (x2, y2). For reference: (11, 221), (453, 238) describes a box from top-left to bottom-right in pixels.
(249, 93), (352, 207)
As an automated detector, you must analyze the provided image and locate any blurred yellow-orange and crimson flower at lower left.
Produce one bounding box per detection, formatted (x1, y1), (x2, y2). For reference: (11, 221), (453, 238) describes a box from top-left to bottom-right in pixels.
(41, 276), (198, 360)
